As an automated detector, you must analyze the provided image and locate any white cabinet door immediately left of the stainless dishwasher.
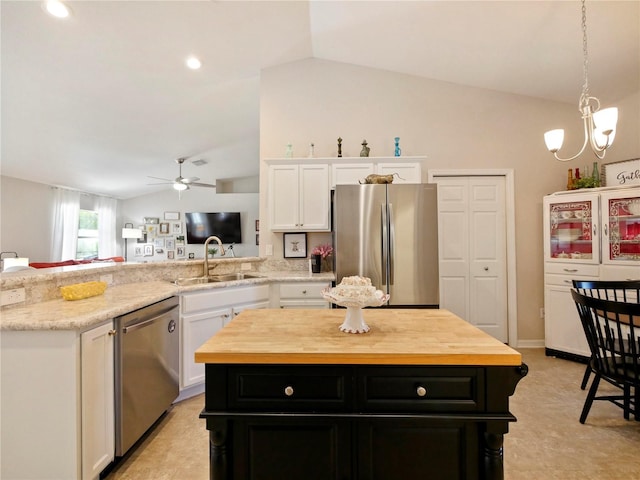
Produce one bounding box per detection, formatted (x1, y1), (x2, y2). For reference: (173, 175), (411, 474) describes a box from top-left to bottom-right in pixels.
(80, 322), (115, 479)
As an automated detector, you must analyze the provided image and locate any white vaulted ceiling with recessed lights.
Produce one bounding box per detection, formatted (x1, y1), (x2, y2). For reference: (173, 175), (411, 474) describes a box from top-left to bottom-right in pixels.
(0, 0), (640, 198)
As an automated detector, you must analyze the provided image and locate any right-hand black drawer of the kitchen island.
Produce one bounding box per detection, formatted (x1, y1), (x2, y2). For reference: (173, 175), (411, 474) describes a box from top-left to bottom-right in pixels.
(358, 367), (484, 412)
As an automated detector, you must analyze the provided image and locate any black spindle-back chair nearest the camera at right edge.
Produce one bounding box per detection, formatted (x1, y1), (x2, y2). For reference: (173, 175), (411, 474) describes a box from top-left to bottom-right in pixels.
(571, 289), (640, 423)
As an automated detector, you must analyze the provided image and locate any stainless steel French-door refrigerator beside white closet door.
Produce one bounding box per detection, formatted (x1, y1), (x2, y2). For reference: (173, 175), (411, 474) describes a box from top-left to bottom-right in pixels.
(333, 184), (439, 307)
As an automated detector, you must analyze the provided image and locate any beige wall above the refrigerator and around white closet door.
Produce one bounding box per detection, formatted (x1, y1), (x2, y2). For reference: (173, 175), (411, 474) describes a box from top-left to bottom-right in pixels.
(260, 59), (640, 341)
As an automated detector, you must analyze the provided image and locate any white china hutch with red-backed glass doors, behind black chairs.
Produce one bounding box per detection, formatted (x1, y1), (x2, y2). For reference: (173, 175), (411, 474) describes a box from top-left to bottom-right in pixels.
(543, 187), (640, 358)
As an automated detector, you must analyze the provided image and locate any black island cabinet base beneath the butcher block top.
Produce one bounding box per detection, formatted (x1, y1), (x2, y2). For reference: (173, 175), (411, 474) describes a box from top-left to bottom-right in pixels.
(200, 365), (527, 480)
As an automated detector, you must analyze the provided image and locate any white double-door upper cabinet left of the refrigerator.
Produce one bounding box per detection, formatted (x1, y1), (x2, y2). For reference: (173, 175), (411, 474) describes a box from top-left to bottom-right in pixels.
(268, 163), (331, 232)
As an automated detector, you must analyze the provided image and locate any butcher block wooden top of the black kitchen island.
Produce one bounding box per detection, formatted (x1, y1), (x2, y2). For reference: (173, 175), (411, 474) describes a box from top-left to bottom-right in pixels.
(195, 308), (522, 366)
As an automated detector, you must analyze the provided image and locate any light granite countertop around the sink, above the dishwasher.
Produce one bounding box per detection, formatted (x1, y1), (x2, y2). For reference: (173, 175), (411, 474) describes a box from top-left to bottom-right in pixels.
(0, 271), (335, 330)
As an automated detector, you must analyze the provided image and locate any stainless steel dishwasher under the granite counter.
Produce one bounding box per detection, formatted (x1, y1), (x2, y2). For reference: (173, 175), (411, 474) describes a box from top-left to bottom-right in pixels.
(115, 297), (180, 457)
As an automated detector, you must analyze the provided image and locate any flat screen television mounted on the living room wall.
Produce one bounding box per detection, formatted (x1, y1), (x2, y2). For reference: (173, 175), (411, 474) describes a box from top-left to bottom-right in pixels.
(185, 212), (242, 244)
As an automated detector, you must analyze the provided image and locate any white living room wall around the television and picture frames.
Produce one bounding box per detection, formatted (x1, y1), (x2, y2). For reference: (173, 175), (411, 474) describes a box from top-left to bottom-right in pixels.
(120, 187), (258, 262)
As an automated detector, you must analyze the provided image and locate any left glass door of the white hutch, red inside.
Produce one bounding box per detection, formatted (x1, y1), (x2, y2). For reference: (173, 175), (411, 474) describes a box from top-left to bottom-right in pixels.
(544, 195), (600, 263)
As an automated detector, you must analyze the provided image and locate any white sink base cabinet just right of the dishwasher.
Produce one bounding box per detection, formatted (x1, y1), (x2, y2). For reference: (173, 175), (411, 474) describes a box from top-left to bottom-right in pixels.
(180, 285), (269, 390)
